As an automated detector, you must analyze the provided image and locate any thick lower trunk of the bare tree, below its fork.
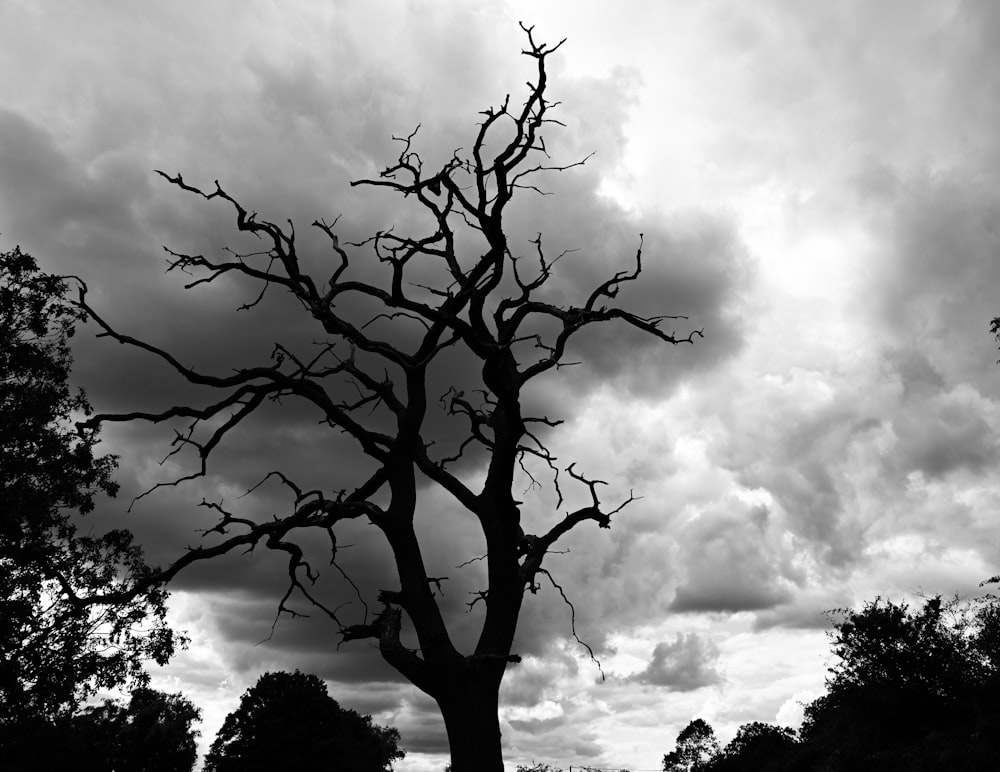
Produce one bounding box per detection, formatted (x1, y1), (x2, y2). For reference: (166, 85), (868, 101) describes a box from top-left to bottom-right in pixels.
(437, 677), (503, 772)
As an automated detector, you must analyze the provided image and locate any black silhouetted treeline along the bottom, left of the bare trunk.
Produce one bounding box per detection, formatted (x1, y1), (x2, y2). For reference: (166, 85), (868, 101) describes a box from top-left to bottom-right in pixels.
(0, 670), (406, 772)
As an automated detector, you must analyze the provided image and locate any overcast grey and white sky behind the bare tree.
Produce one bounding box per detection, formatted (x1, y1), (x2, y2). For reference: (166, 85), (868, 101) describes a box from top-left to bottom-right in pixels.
(0, 0), (1000, 772)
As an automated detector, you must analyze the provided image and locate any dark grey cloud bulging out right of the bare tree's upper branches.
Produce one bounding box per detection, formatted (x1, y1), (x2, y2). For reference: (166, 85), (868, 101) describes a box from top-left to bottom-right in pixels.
(498, 72), (754, 398)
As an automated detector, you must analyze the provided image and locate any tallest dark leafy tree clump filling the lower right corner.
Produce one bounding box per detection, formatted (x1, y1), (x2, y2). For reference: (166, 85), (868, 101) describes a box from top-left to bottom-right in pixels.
(801, 596), (1000, 770)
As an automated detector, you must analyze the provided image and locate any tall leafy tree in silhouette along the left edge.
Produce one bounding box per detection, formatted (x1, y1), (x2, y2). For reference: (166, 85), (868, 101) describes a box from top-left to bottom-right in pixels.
(0, 248), (179, 736)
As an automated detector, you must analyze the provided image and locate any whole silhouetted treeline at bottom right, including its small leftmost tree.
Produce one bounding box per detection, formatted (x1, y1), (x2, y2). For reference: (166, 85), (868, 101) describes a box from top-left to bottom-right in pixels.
(663, 596), (1000, 772)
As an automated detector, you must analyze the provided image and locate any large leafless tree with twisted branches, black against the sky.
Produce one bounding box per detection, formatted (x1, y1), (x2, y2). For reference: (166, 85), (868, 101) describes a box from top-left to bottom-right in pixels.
(70, 25), (701, 772)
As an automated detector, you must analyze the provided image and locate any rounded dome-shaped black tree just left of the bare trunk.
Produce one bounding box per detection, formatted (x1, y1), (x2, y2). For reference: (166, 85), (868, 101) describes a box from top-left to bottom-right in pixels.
(205, 670), (405, 772)
